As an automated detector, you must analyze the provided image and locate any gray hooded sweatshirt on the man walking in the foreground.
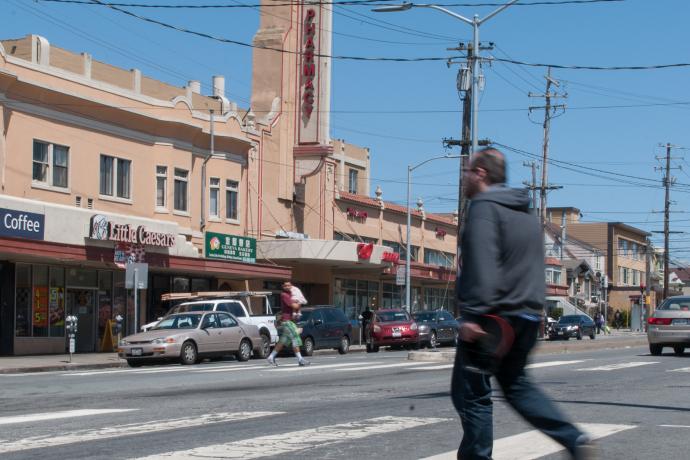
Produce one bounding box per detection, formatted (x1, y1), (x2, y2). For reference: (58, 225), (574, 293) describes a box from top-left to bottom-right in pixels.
(457, 185), (546, 317)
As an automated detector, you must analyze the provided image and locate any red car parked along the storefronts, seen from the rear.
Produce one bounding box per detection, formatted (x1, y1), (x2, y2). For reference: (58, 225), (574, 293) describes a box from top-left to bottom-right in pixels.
(365, 309), (419, 353)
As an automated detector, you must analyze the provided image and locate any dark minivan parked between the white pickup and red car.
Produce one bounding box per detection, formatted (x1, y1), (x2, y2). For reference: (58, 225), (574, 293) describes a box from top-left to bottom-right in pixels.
(297, 305), (352, 356)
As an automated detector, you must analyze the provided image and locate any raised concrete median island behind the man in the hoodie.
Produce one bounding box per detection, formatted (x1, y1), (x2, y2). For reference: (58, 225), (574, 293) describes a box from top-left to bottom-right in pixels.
(407, 336), (647, 362)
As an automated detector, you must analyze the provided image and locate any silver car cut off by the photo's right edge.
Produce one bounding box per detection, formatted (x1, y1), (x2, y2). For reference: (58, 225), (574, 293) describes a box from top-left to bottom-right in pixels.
(647, 296), (690, 356)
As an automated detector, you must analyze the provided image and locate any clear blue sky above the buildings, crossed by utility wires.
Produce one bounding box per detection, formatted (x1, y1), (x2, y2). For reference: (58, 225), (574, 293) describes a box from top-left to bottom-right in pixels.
(0, 0), (690, 259)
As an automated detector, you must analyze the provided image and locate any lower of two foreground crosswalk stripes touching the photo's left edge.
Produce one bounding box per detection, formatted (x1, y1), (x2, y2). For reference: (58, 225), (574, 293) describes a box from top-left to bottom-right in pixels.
(0, 409), (284, 453)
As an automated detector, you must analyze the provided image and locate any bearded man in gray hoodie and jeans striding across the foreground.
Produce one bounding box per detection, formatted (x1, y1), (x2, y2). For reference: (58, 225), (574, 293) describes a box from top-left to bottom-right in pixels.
(451, 148), (592, 460)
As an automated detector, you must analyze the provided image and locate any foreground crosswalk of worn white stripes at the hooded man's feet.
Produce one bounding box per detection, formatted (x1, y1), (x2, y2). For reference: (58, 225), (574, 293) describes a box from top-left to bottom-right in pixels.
(0, 409), (644, 460)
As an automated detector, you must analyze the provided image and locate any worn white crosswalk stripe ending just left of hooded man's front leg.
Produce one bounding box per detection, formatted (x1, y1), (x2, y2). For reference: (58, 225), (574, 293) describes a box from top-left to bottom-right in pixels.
(134, 416), (450, 460)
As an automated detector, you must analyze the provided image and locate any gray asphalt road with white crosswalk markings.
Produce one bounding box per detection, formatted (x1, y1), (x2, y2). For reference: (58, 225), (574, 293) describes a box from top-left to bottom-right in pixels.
(0, 347), (690, 460)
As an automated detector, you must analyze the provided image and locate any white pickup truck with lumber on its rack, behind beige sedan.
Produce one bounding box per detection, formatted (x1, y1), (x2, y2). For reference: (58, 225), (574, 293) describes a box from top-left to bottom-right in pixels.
(141, 291), (278, 356)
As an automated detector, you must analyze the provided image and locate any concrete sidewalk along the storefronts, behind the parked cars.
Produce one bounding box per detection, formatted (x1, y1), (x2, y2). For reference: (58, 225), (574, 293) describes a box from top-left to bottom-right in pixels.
(0, 345), (366, 374)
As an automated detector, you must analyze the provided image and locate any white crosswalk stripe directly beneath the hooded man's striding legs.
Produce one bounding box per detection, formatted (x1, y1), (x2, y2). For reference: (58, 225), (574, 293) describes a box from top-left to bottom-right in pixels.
(416, 423), (636, 460)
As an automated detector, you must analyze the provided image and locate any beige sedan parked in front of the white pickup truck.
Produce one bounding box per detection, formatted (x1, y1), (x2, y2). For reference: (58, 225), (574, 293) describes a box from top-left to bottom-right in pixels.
(118, 311), (266, 367)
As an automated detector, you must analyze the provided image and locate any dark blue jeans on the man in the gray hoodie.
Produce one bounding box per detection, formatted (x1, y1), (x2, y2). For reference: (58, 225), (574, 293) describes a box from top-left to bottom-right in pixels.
(451, 317), (583, 460)
